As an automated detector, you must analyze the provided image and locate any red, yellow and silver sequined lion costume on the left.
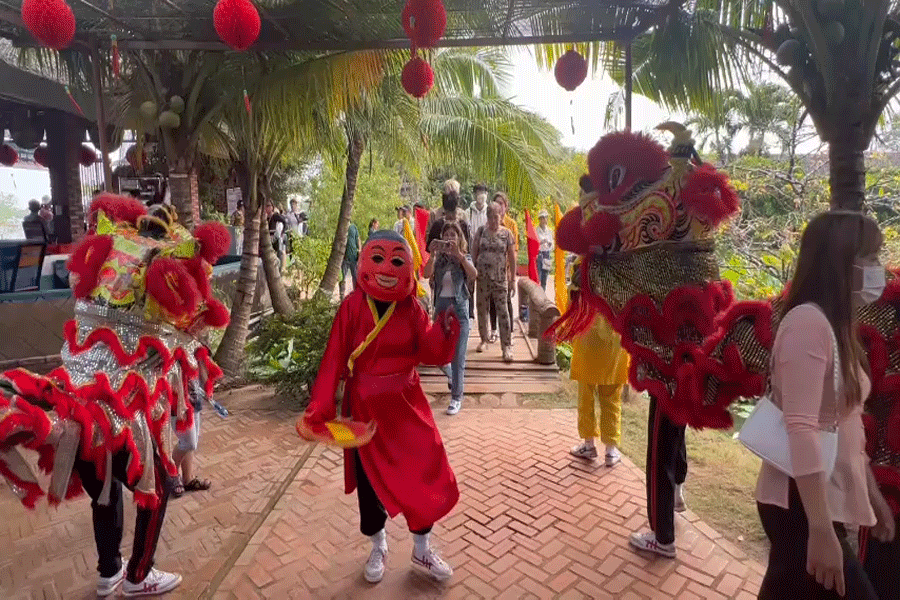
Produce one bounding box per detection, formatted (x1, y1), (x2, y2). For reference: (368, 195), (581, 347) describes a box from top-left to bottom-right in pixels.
(0, 194), (229, 508)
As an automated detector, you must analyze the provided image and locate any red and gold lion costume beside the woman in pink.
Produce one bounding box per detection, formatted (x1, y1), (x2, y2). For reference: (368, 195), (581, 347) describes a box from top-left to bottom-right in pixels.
(548, 123), (744, 428)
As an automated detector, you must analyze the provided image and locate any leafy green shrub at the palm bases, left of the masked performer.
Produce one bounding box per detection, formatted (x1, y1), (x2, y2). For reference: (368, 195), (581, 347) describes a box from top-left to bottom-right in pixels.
(247, 296), (337, 408)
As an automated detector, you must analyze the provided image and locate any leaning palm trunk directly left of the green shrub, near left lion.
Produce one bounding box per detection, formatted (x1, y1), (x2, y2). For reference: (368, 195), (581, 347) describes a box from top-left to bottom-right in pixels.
(215, 169), (262, 375)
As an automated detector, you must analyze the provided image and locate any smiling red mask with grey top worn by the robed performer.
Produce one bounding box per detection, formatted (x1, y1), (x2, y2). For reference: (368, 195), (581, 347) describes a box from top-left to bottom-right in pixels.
(357, 231), (416, 302)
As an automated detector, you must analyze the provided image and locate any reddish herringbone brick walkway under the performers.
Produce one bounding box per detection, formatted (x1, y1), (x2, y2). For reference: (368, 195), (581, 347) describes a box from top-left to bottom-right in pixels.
(0, 389), (763, 600)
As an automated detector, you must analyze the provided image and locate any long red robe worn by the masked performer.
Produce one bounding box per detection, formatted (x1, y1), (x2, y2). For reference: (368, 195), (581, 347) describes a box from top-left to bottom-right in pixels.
(305, 290), (459, 531)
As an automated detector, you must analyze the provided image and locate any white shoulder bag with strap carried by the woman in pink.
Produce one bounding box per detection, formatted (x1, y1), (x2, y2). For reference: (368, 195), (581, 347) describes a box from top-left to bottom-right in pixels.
(738, 310), (841, 478)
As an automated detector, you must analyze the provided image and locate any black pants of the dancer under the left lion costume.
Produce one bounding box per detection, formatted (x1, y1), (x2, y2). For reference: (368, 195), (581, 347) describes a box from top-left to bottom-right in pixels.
(74, 451), (170, 583)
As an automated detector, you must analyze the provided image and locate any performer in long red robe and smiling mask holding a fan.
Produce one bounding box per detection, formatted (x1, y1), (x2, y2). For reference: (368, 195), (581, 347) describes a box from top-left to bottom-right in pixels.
(300, 231), (459, 583)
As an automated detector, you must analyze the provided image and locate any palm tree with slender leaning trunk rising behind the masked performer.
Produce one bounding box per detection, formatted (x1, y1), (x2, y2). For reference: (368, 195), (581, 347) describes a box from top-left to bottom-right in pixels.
(320, 49), (559, 294)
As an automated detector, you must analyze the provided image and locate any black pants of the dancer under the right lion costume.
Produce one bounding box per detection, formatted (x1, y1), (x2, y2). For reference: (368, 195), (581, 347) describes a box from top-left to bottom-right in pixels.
(647, 396), (687, 544)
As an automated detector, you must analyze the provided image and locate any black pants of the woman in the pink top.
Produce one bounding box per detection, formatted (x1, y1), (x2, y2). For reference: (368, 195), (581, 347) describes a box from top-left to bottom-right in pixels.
(757, 479), (876, 600)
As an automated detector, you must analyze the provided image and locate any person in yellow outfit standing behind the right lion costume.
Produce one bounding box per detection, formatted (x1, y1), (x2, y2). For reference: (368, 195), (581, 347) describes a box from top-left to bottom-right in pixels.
(570, 314), (628, 467)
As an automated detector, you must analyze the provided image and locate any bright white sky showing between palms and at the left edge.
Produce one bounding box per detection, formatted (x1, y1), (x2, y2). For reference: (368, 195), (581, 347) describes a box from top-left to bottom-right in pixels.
(0, 47), (683, 230)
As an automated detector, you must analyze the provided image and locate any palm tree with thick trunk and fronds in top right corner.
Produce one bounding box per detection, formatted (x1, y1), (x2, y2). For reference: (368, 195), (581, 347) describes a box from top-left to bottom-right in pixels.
(539, 0), (900, 210)
